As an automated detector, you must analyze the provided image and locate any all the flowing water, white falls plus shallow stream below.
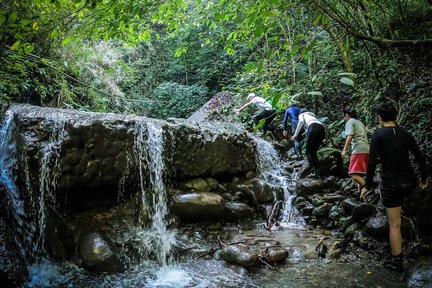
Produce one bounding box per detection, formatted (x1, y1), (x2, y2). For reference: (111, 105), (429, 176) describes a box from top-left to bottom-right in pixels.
(0, 115), (418, 287)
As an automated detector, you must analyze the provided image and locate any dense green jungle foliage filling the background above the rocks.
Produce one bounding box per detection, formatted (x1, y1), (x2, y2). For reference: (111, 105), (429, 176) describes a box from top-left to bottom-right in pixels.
(0, 0), (432, 168)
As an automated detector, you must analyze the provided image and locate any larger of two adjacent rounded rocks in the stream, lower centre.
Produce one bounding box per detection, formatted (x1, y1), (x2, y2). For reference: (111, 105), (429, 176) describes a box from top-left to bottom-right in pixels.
(219, 245), (259, 268)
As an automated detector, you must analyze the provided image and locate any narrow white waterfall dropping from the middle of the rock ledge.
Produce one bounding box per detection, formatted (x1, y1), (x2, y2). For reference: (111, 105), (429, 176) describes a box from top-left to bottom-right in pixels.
(135, 121), (175, 266)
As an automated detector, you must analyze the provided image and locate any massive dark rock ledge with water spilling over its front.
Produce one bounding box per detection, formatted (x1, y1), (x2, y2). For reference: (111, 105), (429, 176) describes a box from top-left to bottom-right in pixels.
(0, 104), (256, 209)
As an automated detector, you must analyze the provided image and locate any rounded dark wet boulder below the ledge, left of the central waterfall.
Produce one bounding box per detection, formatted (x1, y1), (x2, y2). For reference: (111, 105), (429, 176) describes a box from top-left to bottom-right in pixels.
(78, 232), (125, 273)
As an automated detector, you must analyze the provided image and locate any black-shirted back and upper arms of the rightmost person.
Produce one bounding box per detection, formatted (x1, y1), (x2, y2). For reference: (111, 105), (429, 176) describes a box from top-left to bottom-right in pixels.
(371, 126), (422, 183)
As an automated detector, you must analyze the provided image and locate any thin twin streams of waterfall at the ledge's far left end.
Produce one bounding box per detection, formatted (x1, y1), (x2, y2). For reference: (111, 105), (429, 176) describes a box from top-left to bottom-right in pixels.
(0, 111), (67, 260)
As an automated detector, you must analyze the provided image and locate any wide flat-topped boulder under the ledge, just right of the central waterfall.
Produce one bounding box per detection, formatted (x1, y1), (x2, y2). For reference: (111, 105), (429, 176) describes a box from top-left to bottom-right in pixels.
(171, 192), (223, 221)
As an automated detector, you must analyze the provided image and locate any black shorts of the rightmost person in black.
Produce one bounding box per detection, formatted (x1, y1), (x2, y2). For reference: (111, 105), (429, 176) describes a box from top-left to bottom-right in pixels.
(380, 182), (415, 208)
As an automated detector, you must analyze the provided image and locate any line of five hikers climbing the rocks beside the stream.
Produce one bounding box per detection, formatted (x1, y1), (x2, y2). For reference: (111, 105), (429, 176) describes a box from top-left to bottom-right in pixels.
(236, 93), (428, 271)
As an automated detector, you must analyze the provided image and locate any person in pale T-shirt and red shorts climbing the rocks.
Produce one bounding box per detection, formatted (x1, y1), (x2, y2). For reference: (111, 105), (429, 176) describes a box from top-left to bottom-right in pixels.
(341, 108), (369, 193)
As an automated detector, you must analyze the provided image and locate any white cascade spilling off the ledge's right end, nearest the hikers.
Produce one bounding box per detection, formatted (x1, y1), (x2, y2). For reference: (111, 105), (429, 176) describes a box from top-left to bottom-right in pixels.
(251, 135), (305, 228)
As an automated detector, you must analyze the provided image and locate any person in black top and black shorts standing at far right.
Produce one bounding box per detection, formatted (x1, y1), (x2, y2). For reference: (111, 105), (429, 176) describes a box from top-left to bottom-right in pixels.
(360, 104), (428, 271)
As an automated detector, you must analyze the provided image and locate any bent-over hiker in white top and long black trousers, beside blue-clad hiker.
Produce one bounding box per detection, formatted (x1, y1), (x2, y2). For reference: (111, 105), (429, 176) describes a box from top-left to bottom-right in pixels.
(291, 108), (325, 177)
